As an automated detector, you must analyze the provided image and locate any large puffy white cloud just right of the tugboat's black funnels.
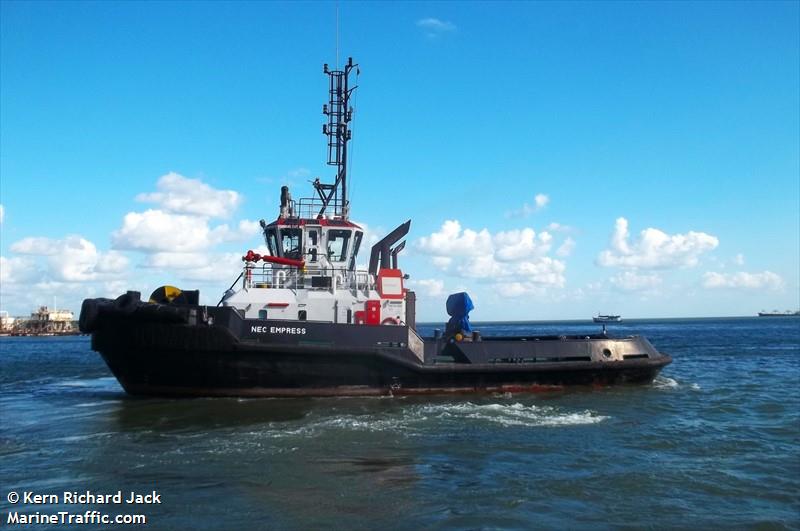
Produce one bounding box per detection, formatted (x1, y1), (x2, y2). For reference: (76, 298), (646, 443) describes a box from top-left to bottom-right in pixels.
(416, 220), (566, 296)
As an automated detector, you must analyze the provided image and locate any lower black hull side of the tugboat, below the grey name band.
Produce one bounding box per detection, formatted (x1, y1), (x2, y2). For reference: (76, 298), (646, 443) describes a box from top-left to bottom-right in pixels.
(95, 342), (668, 396)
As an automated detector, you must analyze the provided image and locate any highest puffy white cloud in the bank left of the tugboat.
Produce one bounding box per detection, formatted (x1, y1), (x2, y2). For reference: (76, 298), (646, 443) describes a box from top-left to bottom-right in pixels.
(136, 172), (242, 218)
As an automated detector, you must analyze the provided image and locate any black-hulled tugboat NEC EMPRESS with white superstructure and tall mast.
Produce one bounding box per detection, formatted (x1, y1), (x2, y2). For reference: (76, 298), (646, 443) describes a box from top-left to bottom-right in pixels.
(79, 58), (672, 396)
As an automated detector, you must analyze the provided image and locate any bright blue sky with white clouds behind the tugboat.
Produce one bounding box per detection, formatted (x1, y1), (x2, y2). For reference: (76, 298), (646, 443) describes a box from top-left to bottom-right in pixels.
(0, 1), (800, 321)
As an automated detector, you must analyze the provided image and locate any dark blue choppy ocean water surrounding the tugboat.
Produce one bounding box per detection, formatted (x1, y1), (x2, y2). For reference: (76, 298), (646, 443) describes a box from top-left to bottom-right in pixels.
(0, 318), (800, 530)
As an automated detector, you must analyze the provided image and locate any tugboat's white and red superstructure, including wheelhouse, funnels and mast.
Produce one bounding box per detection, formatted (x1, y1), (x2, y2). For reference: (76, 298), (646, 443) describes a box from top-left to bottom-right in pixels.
(222, 58), (414, 332)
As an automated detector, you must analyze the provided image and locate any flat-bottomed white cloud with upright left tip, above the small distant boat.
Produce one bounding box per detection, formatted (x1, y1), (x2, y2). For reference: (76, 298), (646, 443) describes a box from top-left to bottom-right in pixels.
(597, 218), (719, 269)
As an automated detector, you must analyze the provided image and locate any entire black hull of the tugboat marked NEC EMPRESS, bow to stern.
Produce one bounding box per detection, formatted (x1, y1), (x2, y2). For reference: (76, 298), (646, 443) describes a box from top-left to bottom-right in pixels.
(86, 300), (671, 397)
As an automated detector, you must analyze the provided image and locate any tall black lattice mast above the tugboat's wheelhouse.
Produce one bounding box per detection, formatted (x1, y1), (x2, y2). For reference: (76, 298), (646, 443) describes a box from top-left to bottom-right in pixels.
(314, 57), (359, 219)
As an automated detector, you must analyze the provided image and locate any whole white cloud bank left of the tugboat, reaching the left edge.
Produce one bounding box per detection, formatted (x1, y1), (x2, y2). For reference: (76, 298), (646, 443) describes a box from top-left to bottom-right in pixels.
(0, 173), (260, 312)
